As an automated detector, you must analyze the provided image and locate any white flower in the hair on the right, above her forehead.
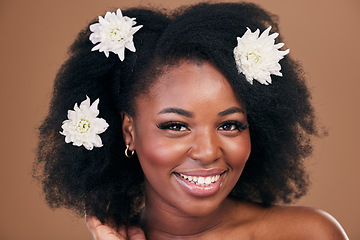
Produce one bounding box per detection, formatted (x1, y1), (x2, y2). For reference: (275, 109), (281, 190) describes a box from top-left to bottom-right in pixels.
(234, 27), (290, 85)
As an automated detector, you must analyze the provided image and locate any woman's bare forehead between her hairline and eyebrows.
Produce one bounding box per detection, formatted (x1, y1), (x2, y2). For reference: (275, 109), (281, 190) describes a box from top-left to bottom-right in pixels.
(136, 61), (242, 114)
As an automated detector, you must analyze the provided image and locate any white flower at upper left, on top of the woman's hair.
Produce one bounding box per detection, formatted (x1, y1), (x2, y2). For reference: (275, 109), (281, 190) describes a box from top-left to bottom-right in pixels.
(90, 9), (142, 61)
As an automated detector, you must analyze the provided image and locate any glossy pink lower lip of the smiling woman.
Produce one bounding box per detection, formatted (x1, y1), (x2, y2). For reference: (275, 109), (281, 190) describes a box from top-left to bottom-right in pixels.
(174, 173), (226, 197)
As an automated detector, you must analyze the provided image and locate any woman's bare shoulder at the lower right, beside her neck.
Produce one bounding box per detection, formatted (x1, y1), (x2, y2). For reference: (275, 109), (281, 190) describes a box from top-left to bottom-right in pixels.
(227, 202), (348, 240)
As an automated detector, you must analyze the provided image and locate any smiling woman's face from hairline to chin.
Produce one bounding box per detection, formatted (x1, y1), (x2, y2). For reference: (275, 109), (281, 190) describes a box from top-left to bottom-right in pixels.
(125, 62), (251, 216)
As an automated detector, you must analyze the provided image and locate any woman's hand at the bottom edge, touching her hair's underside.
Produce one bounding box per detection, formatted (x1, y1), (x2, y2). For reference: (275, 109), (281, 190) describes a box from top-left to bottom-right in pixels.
(85, 216), (146, 240)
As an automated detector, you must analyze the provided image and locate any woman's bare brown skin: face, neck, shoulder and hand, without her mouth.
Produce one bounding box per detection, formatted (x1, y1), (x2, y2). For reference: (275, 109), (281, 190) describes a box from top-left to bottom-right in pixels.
(88, 62), (347, 240)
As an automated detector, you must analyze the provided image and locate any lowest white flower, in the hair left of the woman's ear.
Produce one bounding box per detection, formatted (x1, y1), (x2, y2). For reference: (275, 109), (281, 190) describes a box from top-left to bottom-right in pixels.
(60, 96), (109, 150)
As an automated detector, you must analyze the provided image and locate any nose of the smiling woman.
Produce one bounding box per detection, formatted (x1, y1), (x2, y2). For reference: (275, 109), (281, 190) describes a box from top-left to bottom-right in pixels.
(189, 129), (221, 163)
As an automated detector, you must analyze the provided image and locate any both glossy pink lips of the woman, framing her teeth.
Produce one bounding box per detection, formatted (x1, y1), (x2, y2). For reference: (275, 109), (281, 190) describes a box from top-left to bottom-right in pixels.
(173, 169), (227, 197)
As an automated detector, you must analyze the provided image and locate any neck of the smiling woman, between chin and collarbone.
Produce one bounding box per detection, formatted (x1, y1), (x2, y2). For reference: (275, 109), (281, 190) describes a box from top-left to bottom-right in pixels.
(142, 194), (233, 240)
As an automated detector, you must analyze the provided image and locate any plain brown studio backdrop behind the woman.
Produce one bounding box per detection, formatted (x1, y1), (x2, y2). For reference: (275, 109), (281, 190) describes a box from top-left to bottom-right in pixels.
(0, 0), (360, 240)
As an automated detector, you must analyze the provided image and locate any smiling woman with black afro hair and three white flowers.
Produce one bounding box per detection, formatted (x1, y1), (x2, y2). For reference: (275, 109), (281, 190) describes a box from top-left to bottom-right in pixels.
(35, 3), (347, 240)
